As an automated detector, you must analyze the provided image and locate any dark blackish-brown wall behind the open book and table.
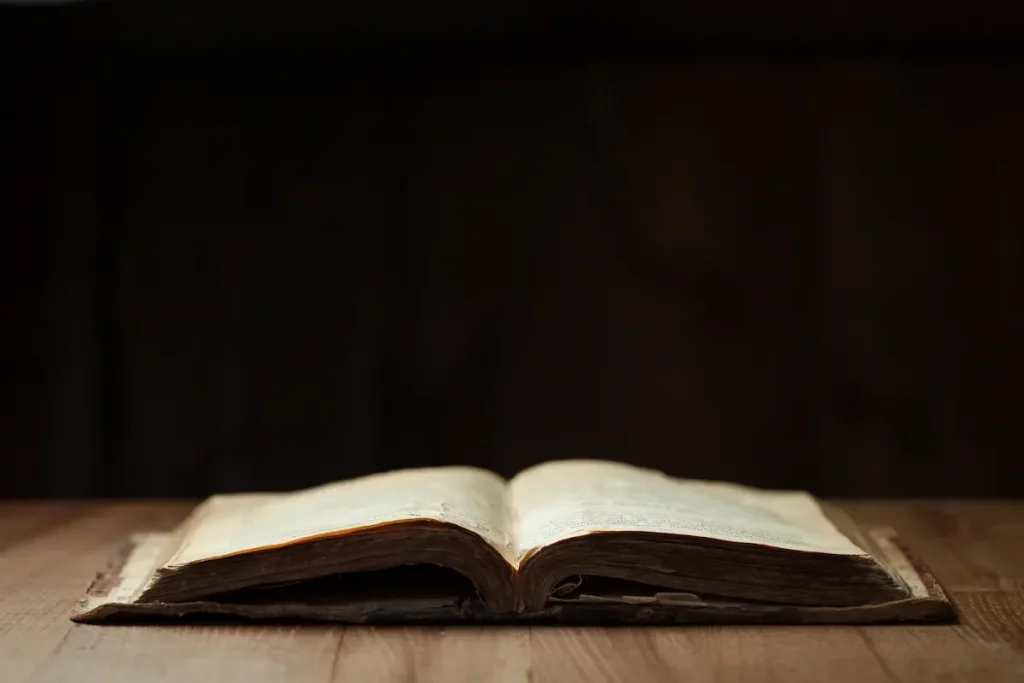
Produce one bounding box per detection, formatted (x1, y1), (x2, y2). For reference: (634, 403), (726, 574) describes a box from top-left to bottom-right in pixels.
(0, 0), (1024, 497)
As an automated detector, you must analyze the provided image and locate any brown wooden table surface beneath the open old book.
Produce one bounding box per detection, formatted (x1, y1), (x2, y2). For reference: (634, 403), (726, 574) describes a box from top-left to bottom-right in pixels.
(0, 502), (1024, 683)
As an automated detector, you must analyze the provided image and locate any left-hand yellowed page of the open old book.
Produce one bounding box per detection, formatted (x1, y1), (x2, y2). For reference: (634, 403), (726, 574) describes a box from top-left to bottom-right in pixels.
(165, 467), (520, 567)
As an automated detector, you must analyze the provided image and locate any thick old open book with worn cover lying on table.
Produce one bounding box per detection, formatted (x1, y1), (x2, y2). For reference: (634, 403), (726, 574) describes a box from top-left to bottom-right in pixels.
(73, 461), (954, 623)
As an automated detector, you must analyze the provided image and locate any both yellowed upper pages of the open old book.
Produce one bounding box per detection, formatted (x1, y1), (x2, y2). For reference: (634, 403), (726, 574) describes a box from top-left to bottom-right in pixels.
(159, 460), (865, 567)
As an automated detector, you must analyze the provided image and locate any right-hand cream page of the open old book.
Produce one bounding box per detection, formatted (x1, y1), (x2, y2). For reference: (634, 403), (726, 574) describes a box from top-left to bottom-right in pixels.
(509, 460), (865, 564)
